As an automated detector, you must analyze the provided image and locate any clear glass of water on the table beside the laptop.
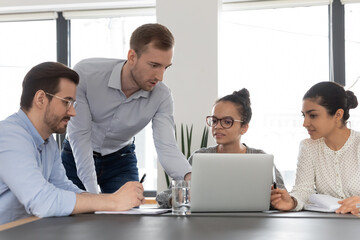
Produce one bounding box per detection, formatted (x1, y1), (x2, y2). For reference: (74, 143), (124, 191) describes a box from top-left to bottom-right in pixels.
(171, 180), (191, 215)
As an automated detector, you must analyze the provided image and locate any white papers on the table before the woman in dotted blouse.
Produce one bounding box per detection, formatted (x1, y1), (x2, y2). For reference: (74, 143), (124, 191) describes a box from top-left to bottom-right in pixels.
(304, 194), (341, 212)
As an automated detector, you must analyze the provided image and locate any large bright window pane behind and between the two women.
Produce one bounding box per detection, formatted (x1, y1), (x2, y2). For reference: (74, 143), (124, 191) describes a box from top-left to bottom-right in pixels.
(218, 6), (329, 190)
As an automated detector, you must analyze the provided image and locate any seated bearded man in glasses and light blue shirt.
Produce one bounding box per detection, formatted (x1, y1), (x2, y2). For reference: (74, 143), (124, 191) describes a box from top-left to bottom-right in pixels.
(0, 62), (144, 224)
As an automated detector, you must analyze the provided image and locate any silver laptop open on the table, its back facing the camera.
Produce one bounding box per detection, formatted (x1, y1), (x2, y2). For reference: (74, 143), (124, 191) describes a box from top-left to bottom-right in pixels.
(191, 153), (274, 212)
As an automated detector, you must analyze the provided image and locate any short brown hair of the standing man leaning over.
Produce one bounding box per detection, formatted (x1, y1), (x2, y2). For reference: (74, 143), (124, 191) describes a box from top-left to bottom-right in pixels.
(130, 23), (175, 56)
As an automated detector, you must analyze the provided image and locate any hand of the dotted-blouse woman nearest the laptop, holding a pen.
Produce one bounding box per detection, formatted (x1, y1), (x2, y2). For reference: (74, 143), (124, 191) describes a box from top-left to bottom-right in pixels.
(270, 189), (296, 211)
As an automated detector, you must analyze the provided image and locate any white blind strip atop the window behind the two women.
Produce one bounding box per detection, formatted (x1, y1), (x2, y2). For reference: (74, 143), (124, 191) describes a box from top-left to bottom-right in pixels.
(223, 0), (334, 11)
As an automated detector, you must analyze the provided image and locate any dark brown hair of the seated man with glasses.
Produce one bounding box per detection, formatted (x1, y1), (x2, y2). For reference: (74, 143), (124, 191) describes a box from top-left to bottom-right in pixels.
(20, 62), (79, 111)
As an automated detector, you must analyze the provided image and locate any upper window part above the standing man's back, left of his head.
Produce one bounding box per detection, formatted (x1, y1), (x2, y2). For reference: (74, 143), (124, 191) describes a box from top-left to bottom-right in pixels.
(71, 16), (155, 66)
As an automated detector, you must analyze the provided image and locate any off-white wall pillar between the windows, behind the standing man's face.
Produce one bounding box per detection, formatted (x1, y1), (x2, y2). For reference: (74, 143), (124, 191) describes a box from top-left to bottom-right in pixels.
(156, 0), (220, 191)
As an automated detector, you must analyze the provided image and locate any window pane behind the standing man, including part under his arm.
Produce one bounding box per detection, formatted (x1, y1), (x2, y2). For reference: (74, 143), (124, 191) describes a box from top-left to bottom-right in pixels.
(71, 16), (157, 190)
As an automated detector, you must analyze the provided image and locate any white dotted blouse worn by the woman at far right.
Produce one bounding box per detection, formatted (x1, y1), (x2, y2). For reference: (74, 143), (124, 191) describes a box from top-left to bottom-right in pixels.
(290, 130), (360, 211)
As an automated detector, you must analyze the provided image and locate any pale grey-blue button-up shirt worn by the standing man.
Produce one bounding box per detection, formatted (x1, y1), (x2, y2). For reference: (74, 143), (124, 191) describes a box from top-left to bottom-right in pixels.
(67, 58), (191, 193)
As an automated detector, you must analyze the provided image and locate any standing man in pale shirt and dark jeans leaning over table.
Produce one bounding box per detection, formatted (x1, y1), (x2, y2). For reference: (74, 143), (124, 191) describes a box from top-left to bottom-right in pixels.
(62, 24), (191, 193)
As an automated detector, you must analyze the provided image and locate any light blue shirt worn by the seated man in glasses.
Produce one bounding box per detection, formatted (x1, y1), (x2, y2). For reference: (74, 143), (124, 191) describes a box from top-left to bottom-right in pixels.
(0, 110), (82, 224)
